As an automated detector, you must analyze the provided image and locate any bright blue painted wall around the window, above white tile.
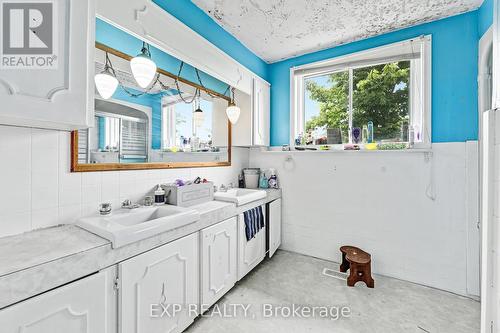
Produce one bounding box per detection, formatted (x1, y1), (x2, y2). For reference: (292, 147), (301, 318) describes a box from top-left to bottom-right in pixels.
(269, 11), (479, 146)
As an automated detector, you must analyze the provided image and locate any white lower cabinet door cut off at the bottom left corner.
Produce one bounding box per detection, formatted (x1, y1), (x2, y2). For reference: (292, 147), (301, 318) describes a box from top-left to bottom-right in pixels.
(0, 270), (116, 333)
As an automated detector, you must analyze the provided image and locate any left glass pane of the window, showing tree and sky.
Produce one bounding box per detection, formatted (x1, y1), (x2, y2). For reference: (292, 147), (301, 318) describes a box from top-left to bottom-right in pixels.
(301, 71), (349, 144)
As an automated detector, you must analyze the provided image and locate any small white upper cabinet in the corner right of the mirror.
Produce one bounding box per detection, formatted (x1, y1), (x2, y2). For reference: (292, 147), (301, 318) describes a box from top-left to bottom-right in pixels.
(232, 77), (271, 147)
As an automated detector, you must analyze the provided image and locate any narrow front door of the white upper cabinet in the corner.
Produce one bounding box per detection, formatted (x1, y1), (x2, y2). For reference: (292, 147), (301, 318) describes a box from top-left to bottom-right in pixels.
(253, 78), (271, 146)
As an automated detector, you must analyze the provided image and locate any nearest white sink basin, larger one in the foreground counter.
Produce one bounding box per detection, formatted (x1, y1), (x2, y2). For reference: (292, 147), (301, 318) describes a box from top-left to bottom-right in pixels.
(77, 205), (200, 248)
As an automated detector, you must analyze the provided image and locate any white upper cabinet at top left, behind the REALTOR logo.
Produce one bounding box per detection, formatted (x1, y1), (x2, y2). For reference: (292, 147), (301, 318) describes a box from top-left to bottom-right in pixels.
(0, 0), (95, 130)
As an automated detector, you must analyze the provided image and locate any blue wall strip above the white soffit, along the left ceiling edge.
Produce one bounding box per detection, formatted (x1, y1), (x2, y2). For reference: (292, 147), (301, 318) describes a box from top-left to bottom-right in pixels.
(153, 0), (268, 80)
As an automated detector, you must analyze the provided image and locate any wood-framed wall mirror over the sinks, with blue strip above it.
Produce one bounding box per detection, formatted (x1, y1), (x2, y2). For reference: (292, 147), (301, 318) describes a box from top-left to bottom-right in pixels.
(71, 19), (234, 172)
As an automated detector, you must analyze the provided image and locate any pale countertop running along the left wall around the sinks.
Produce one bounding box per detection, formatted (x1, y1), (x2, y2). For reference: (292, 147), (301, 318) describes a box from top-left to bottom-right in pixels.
(0, 190), (281, 308)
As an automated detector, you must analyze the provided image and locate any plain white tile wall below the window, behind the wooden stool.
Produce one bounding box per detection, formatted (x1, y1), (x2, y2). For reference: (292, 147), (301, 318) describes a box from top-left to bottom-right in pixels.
(250, 143), (479, 294)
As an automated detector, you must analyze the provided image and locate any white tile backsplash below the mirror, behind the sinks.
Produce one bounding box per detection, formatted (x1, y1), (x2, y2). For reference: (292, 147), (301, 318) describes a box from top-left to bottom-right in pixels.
(0, 126), (249, 237)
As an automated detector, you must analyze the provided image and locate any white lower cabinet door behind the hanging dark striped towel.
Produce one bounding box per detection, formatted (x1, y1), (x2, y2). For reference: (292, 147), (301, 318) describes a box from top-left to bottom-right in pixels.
(238, 205), (267, 281)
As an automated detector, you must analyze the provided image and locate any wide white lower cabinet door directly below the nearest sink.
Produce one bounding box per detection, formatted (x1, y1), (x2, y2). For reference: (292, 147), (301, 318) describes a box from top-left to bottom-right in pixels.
(119, 233), (199, 333)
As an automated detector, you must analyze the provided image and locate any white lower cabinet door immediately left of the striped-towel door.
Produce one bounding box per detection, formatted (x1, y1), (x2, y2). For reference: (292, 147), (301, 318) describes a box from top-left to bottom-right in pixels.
(201, 217), (238, 308)
